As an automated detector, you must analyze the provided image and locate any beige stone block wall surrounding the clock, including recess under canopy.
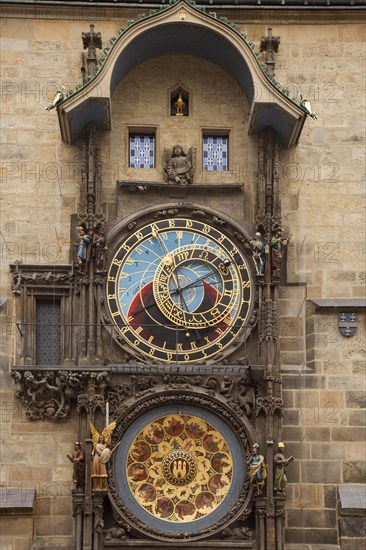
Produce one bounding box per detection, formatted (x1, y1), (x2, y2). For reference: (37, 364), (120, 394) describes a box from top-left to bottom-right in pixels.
(0, 2), (366, 550)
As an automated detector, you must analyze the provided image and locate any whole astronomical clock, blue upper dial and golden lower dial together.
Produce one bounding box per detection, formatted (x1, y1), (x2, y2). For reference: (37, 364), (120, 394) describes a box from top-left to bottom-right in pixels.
(100, 206), (256, 541)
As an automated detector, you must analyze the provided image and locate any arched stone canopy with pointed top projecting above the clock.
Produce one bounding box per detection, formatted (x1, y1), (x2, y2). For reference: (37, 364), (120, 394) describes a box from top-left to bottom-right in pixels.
(57, 0), (309, 147)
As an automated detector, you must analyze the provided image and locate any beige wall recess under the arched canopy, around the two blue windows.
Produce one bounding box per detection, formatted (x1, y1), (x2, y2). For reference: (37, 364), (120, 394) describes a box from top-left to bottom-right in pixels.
(102, 54), (257, 223)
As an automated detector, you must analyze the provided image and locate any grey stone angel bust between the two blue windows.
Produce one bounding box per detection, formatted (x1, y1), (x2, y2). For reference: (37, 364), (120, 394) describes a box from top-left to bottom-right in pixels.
(164, 145), (196, 185)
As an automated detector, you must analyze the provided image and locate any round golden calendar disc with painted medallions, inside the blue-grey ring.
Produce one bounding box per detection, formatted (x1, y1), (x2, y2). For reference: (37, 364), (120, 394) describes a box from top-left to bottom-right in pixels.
(126, 414), (233, 523)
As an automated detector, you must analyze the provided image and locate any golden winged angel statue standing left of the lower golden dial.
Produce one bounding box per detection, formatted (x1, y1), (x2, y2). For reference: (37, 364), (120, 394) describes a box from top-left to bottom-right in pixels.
(90, 422), (116, 491)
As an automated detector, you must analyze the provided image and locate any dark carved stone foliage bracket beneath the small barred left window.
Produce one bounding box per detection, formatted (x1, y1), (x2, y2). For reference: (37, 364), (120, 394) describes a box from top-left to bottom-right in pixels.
(12, 368), (108, 420)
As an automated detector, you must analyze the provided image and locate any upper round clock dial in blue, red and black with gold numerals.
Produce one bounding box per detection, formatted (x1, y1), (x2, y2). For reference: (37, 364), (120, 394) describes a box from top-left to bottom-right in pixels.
(107, 217), (253, 363)
